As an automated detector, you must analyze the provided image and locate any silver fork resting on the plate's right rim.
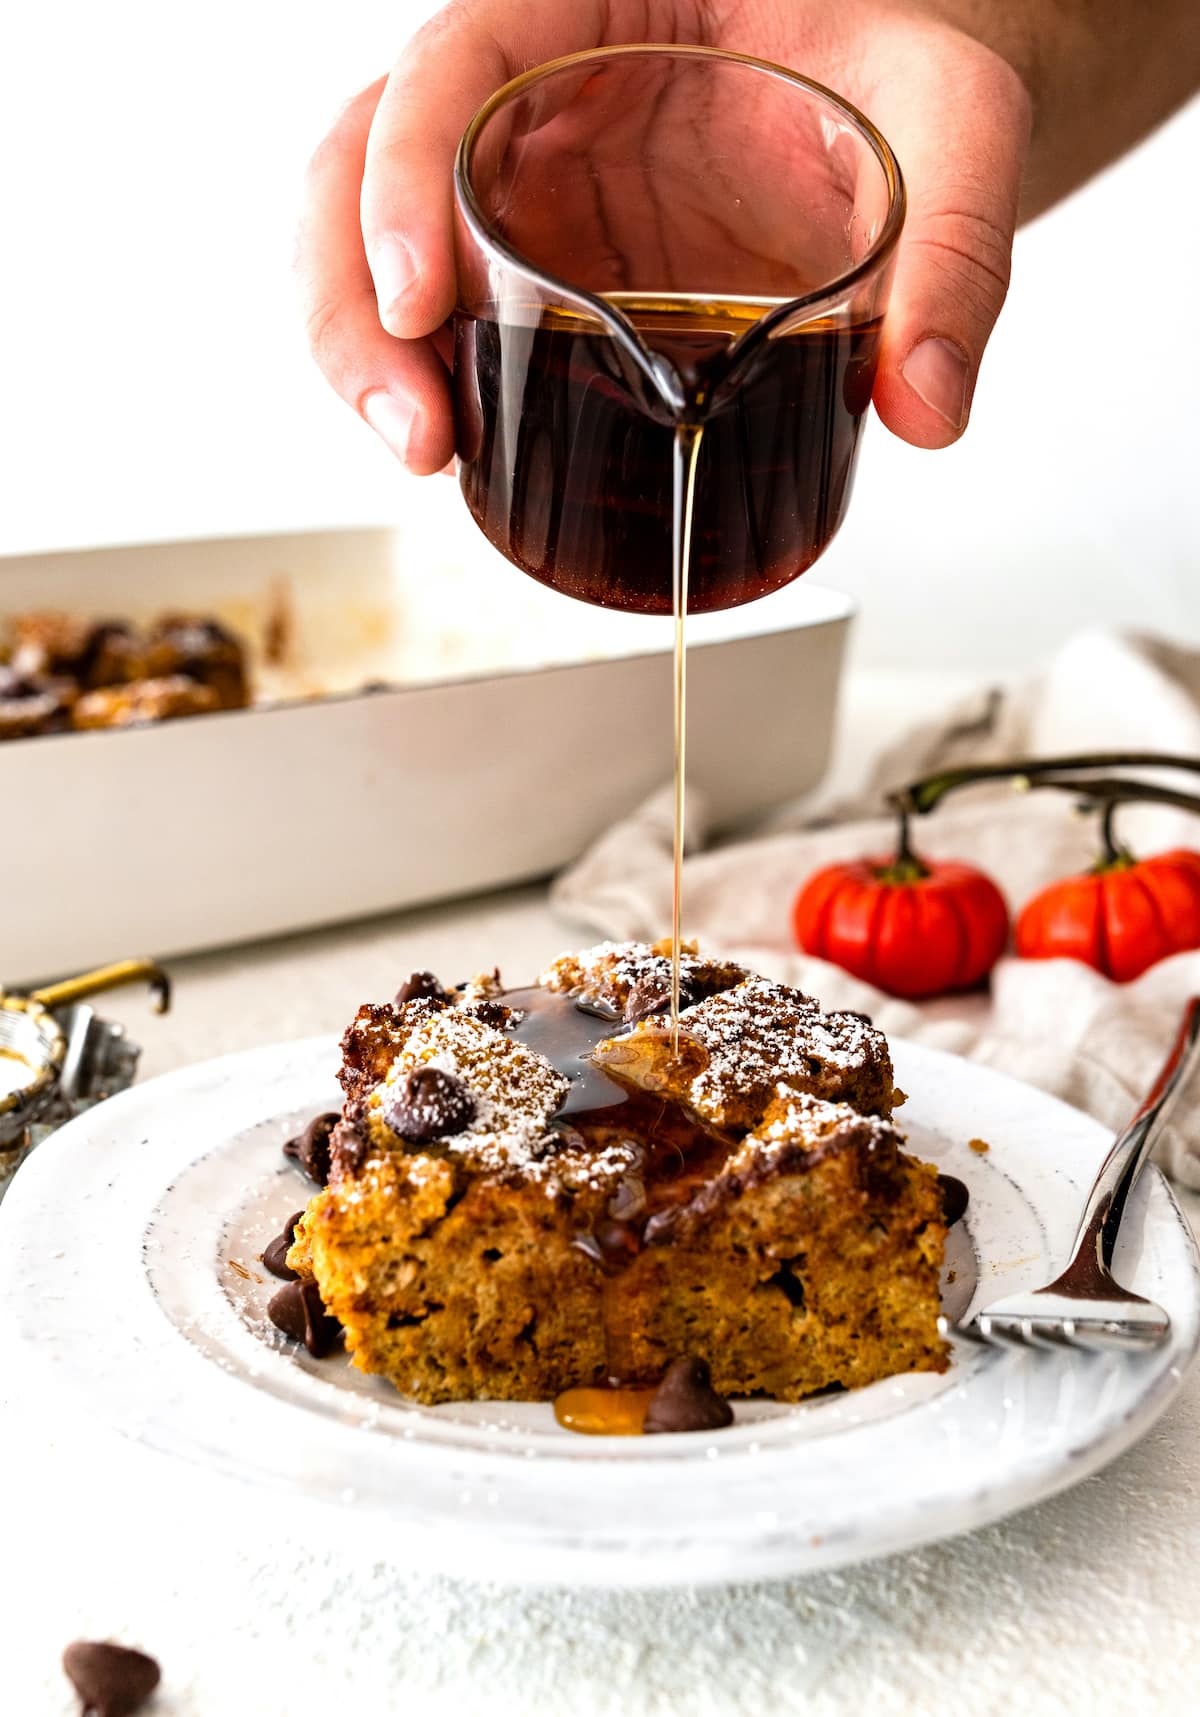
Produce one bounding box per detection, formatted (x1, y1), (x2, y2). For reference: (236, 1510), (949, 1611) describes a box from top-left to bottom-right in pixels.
(941, 996), (1200, 1350)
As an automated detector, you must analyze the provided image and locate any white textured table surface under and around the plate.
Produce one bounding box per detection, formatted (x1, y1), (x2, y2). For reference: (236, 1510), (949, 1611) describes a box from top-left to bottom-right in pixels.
(0, 673), (1200, 1717)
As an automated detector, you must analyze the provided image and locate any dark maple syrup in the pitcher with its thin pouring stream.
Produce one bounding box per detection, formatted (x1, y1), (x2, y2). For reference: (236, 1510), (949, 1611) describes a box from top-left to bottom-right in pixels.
(453, 292), (881, 1053)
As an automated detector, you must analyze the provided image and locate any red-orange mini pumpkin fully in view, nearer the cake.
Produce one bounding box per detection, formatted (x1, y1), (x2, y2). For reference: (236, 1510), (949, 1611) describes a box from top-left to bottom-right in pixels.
(791, 852), (1008, 998)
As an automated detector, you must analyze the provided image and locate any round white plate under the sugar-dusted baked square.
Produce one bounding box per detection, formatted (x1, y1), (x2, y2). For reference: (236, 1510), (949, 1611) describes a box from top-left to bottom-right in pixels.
(0, 1039), (1200, 1587)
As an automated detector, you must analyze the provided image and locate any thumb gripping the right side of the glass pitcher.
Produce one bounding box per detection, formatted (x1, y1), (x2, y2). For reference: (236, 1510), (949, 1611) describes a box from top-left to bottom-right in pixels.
(874, 31), (1030, 448)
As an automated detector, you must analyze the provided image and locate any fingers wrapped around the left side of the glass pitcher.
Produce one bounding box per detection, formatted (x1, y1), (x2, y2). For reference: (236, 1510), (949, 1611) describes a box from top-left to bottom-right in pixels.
(297, 0), (618, 476)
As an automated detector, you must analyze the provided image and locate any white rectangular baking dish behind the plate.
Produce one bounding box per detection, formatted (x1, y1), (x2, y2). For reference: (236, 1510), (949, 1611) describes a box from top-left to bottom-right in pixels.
(0, 508), (852, 986)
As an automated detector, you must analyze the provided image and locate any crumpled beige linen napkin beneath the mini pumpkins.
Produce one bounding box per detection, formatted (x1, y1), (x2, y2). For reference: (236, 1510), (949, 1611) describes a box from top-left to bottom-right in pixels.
(553, 632), (1200, 1186)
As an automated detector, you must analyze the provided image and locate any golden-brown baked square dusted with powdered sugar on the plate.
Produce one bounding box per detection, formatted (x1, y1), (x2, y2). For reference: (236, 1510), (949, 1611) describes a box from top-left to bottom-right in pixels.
(288, 944), (946, 1403)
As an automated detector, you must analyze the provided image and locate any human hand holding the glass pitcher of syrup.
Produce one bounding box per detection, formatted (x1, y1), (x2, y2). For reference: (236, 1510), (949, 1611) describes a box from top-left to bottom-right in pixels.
(299, 0), (1032, 474)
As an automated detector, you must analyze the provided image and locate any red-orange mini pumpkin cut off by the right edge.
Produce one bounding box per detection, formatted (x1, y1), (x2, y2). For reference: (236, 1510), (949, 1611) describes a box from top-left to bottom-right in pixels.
(1016, 848), (1200, 984)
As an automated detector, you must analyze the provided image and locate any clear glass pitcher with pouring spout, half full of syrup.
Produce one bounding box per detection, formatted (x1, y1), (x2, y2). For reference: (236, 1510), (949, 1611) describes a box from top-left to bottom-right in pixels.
(453, 46), (905, 613)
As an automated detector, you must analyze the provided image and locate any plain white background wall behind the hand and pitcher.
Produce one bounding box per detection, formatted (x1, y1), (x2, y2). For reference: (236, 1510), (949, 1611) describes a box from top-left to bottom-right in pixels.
(0, 0), (1200, 670)
